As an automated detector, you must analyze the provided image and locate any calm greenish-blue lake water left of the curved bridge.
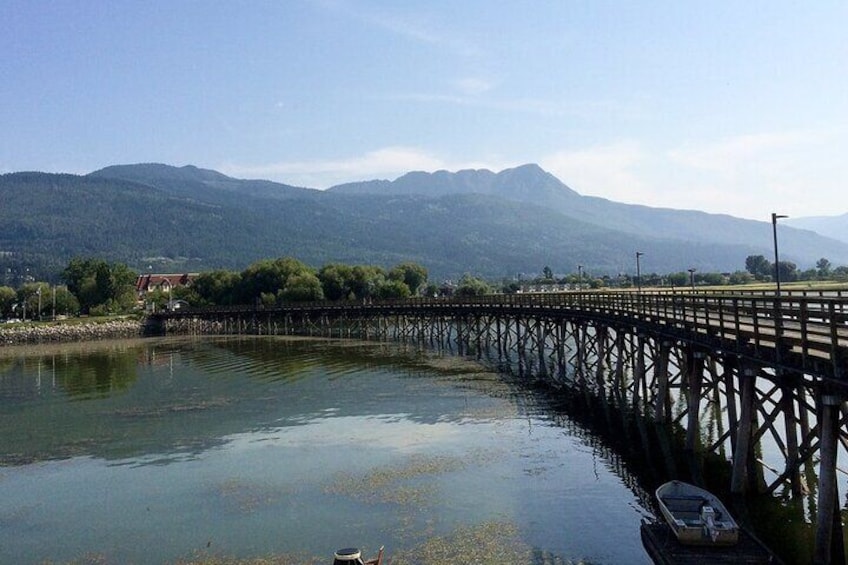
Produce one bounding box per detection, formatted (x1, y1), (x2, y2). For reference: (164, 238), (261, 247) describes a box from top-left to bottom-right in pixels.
(0, 337), (652, 565)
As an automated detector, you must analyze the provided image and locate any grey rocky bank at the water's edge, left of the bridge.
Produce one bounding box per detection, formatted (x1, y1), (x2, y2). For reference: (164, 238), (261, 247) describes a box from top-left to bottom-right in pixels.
(0, 319), (156, 347)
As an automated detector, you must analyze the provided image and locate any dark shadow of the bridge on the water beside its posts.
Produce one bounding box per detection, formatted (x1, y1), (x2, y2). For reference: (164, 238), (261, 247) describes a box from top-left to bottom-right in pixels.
(444, 338), (816, 565)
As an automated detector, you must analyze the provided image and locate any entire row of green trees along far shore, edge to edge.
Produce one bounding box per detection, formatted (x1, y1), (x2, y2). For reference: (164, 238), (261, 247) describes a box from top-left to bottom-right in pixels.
(0, 255), (848, 320)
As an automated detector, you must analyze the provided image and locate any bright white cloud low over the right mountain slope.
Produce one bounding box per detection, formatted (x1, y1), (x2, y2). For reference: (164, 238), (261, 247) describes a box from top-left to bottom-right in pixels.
(540, 131), (844, 219)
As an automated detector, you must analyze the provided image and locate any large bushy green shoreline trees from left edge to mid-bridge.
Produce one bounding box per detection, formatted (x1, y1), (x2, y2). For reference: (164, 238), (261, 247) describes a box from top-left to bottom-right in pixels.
(0, 257), (439, 320)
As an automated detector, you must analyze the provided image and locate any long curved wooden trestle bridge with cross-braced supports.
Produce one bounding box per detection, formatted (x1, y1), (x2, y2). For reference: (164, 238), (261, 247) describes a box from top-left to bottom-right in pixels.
(156, 291), (848, 563)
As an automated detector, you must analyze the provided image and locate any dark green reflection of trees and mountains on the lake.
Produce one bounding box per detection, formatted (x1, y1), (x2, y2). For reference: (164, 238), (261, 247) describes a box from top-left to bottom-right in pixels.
(0, 337), (510, 465)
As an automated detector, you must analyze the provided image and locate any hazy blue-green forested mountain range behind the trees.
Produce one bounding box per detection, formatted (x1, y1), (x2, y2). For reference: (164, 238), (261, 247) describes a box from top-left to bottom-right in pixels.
(0, 164), (848, 282)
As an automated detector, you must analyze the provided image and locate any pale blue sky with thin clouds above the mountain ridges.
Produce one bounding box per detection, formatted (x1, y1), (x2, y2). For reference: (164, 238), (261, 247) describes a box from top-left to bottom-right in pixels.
(0, 0), (848, 221)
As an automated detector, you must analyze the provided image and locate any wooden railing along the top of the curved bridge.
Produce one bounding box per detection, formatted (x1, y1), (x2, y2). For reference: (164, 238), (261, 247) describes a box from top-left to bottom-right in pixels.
(165, 291), (848, 378)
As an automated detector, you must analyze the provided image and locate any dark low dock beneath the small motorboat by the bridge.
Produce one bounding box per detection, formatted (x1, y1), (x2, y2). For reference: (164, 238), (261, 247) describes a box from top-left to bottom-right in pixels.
(641, 522), (781, 565)
